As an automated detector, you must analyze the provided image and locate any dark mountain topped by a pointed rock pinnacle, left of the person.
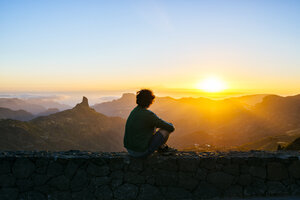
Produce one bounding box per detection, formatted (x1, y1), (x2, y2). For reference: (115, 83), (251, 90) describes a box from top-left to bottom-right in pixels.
(0, 97), (125, 151)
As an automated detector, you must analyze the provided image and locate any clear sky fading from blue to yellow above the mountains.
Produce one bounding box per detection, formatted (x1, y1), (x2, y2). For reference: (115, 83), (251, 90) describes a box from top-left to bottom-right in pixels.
(0, 0), (300, 96)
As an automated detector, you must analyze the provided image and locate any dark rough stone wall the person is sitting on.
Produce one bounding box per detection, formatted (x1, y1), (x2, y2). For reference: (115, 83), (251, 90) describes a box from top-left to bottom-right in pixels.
(0, 151), (300, 200)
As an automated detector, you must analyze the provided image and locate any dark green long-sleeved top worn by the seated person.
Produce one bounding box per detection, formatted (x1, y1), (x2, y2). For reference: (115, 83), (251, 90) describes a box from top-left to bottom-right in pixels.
(124, 106), (174, 152)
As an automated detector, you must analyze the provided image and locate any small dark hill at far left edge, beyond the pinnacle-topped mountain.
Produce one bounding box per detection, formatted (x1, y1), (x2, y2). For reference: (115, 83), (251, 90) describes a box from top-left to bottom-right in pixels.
(0, 107), (34, 121)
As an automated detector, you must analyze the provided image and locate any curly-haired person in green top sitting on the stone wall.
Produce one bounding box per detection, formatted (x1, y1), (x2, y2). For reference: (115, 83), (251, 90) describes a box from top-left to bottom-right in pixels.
(124, 89), (174, 157)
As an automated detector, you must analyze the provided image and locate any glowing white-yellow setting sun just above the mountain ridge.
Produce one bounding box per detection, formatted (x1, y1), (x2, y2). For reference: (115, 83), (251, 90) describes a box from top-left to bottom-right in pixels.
(196, 77), (227, 92)
